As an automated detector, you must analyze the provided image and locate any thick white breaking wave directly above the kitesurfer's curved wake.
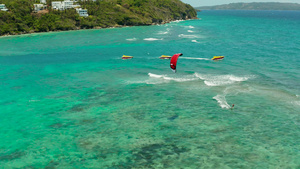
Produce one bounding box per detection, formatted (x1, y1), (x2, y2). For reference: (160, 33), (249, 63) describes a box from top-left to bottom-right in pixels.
(195, 73), (251, 86)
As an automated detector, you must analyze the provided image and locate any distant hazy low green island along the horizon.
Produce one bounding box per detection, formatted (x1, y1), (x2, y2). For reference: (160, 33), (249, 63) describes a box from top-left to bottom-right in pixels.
(197, 2), (300, 10)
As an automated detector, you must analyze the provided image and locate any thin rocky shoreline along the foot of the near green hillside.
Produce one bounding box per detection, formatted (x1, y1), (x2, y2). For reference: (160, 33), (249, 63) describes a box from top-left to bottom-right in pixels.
(0, 17), (199, 38)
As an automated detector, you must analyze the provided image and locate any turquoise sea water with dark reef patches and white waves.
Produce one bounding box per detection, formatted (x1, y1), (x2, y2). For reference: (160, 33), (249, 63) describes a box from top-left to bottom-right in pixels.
(0, 11), (300, 169)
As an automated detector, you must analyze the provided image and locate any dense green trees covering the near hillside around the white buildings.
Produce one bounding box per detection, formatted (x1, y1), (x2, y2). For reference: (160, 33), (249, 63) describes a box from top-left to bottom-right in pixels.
(0, 0), (197, 35)
